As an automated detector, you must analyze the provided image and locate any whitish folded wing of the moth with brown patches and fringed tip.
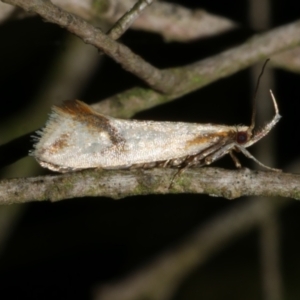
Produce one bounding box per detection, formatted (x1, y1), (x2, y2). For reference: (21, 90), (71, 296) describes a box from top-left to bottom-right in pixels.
(31, 100), (234, 172)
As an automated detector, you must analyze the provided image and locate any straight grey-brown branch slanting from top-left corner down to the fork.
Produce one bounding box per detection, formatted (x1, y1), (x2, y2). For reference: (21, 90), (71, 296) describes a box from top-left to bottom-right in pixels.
(2, 0), (169, 92)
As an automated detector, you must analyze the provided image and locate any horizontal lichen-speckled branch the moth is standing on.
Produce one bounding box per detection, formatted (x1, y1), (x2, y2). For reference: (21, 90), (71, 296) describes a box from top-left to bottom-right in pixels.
(0, 167), (300, 204)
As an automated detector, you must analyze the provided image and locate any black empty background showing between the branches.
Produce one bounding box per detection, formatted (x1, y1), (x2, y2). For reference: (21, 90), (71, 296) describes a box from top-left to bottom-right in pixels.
(0, 0), (300, 300)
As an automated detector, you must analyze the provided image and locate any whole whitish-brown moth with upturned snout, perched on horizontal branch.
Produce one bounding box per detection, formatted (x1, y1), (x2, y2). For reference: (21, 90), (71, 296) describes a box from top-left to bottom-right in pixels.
(30, 91), (281, 172)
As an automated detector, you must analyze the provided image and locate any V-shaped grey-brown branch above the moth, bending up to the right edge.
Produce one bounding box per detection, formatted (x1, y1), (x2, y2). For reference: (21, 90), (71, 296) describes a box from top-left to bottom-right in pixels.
(3, 0), (300, 97)
